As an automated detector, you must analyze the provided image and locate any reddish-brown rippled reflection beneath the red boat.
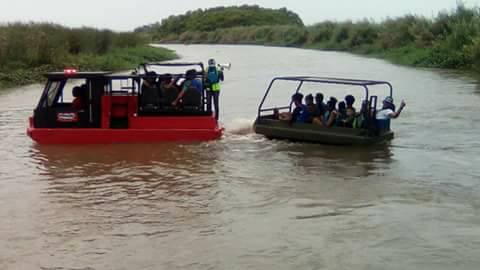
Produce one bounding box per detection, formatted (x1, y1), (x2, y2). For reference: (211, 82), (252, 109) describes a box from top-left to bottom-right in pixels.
(32, 144), (223, 210)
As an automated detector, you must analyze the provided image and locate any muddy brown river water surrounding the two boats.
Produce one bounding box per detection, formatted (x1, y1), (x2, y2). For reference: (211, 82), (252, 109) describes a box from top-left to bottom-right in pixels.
(0, 45), (480, 270)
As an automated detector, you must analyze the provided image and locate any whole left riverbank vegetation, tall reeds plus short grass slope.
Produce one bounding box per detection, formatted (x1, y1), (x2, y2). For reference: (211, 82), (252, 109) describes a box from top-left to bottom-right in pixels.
(0, 23), (175, 87)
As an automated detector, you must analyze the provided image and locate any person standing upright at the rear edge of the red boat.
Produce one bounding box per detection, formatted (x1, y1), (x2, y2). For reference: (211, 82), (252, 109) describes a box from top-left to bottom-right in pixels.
(206, 59), (224, 120)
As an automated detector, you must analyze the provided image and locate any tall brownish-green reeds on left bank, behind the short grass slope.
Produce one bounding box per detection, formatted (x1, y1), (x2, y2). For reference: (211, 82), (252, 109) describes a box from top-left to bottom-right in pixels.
(0, 23), (152, 70)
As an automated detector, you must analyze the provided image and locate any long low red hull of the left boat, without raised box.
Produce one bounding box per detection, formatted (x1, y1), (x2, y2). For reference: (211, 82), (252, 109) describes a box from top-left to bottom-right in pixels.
(27, 116), (223, 144)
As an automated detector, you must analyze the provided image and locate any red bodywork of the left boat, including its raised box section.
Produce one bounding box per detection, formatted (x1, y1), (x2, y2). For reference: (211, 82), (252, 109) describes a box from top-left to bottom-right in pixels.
(27, 74), (223, 144)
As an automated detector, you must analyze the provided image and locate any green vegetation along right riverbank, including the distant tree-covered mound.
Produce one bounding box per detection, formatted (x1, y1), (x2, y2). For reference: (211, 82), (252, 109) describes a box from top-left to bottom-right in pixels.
(137, 4), (480, 71)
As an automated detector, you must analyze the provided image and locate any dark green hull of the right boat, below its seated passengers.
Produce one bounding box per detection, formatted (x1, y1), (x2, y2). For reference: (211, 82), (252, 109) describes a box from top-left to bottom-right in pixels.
(254, 118), (394, 145)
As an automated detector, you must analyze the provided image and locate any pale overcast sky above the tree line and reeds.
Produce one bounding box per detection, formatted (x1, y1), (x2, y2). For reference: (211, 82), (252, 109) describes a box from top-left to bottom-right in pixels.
(0, 0), (480, 30)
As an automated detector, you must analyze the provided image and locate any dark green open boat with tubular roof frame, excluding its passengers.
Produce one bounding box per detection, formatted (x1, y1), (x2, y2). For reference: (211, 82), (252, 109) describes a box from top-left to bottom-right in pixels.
(254, 76), (394, 145)
